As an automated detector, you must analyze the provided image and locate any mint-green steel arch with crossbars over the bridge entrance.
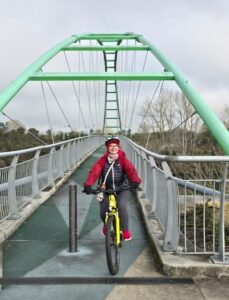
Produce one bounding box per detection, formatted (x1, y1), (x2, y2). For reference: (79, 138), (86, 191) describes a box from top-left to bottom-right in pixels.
(0, 33), (229, 155)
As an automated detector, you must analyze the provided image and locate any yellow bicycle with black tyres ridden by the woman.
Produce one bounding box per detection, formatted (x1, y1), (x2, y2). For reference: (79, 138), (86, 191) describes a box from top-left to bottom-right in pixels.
(92, 186), (131, 275)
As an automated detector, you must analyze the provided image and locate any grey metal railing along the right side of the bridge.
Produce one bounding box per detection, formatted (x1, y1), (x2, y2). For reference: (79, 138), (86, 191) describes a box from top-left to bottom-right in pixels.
(122, 138), (229, 263)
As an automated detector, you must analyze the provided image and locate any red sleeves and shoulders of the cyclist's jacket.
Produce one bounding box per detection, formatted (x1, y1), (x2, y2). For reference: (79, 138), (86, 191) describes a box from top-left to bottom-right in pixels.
(84, 150), (141, 186)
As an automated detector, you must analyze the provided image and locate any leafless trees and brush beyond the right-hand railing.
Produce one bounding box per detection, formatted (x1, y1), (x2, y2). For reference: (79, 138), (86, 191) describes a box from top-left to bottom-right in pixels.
(128, 90), (229, 179)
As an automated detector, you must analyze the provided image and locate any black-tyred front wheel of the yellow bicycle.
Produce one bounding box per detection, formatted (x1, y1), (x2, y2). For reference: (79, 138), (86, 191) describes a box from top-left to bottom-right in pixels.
(105, 216), (120, 275)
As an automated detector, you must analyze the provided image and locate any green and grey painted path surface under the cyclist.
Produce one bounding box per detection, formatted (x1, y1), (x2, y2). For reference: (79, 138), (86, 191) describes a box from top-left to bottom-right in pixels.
(0, 148), (229, 300)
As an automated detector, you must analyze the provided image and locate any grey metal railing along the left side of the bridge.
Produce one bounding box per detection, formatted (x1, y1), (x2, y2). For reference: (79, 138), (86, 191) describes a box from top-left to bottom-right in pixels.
(0, 136), (104, 221)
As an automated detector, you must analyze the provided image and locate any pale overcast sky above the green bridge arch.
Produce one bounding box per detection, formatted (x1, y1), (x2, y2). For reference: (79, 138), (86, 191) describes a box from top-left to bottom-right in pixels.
(0, 0), (229, 132)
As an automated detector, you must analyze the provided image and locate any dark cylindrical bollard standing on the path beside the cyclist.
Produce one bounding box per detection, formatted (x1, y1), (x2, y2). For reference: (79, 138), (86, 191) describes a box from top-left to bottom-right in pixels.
(69, 184), (77, 253)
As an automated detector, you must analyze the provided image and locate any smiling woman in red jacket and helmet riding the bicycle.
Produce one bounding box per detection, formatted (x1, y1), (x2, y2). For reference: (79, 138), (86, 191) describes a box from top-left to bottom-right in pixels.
(84, 136), (141, 241)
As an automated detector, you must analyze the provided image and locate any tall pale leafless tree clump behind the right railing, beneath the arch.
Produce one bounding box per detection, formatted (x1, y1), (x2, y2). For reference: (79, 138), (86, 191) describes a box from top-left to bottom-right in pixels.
(140, 90), (200, 154)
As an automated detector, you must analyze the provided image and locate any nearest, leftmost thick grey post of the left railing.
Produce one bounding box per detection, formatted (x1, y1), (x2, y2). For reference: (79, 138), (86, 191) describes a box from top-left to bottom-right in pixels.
(8, 155), (20, 219)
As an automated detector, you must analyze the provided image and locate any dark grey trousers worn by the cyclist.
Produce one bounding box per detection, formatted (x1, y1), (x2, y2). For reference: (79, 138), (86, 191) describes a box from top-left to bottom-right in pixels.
(100, 191), (129, 230)
